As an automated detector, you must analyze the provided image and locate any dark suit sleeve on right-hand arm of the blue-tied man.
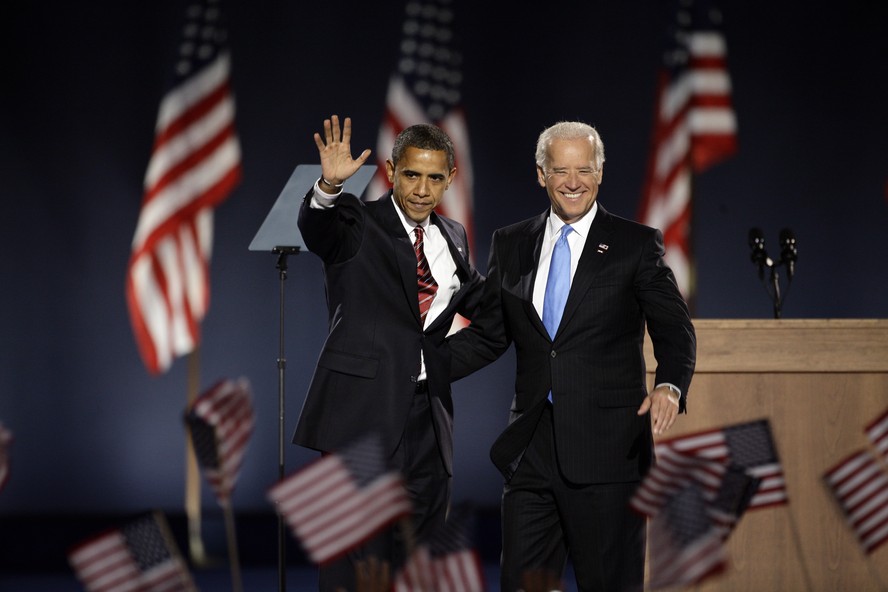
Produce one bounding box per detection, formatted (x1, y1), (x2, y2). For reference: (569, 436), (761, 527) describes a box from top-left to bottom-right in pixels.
(636, 230), (697, 413)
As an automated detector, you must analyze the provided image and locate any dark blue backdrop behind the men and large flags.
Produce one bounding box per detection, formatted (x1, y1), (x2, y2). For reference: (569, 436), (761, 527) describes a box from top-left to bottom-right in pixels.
(0, 0), (888, 516)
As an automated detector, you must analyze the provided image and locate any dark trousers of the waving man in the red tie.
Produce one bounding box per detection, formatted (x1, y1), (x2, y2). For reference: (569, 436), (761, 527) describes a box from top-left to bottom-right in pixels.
(318, 393), (451, 592)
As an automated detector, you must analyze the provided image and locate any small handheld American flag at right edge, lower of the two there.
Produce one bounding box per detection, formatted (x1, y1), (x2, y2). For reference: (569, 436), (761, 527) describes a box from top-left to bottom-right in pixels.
(823, 450), (888, 554)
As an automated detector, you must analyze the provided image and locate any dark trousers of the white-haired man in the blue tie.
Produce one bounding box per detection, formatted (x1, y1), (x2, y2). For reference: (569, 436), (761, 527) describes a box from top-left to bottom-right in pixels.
(501, 406), (645, 592)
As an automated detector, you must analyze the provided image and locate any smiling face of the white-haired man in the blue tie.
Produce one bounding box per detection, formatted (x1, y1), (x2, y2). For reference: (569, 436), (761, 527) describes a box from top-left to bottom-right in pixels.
(537, 138), (603, 224)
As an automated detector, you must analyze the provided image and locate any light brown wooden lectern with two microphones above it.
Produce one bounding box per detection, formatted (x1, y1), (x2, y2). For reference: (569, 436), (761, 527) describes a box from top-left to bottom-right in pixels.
(645, 319), (888, 592)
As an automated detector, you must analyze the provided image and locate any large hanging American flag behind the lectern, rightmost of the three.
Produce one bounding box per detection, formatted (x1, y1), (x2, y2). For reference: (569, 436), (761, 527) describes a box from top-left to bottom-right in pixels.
(638, 0), (737, 300)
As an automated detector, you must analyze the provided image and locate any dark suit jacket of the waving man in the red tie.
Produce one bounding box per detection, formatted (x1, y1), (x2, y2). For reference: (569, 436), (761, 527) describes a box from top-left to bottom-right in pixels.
(293, 190), (483, 474)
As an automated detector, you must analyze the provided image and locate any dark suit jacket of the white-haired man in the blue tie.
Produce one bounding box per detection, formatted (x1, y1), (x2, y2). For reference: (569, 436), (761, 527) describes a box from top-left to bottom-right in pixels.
(450, 203), (696, 484)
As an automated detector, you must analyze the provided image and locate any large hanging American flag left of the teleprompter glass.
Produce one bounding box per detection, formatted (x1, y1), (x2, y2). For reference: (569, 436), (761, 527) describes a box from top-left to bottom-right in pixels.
(126, 0), (241, 374)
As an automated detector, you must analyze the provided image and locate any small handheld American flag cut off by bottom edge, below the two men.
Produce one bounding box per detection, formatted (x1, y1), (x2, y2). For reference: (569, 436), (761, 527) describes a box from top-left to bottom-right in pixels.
(394, 507), (487, 592)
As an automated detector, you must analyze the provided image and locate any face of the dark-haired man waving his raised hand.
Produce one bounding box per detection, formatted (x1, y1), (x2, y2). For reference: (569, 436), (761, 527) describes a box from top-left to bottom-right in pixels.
(385, 146), (456, 224)
